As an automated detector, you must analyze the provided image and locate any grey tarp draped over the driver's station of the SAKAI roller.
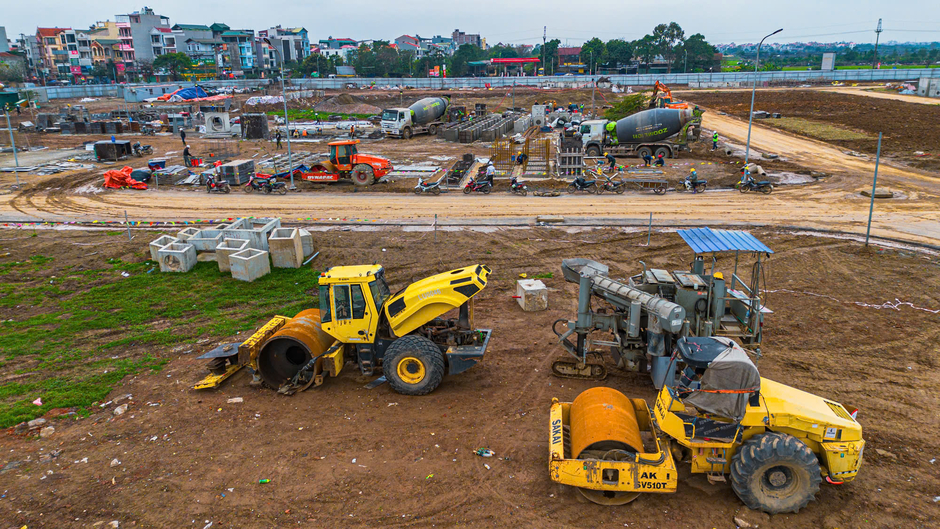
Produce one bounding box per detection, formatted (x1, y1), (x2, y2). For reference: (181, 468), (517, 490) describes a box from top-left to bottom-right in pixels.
(685, 337), (760, 421)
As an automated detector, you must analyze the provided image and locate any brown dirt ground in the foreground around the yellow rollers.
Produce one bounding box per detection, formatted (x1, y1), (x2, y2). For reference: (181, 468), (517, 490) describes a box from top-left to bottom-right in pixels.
(0, 228), (940, 528)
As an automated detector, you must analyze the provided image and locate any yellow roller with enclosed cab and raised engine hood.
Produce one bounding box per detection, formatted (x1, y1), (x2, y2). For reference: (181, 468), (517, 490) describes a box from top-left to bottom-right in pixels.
(195, 265), (491, 395)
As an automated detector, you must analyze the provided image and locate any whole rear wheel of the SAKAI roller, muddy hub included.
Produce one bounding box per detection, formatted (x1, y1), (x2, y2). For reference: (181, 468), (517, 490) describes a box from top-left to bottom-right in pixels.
(731, 433), (822, 514)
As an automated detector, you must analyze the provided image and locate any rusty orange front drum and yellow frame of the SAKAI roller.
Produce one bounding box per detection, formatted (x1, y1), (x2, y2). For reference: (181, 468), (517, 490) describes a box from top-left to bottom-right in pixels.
(549, 387), (678, 505)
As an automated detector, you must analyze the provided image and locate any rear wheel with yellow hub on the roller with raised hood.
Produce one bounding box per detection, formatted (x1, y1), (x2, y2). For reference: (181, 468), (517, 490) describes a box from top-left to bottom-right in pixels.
(390, 334), (444, 396)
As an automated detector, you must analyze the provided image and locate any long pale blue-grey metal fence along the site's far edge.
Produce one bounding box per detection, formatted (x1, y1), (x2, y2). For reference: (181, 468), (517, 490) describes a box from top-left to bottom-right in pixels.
(22, 68), (940, 101)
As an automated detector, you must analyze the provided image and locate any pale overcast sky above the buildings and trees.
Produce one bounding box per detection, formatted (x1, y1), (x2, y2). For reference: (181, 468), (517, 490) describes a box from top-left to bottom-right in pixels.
(0, 0), (940, 45)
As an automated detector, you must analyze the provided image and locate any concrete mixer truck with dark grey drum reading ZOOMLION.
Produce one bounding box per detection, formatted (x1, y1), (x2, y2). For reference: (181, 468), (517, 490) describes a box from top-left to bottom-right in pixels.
(580, 108), (702, 158)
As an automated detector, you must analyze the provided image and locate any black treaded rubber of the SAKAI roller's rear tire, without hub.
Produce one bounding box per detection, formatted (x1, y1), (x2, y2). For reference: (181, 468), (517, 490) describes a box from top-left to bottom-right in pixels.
(731, 432), (822, 514)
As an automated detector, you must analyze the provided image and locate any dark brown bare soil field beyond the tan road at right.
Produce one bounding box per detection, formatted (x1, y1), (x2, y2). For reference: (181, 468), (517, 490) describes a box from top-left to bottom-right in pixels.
(684, 90), (940, 171)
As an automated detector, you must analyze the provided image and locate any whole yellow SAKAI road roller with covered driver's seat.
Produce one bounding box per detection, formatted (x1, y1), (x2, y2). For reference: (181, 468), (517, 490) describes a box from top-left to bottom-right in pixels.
(549, 337), (865, 514)
